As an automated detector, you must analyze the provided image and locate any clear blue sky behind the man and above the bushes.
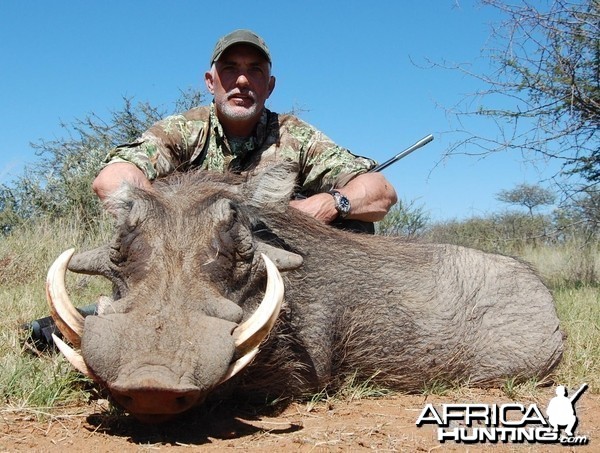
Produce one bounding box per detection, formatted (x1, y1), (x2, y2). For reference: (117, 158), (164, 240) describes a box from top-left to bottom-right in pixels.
(0, 0), (555, 220)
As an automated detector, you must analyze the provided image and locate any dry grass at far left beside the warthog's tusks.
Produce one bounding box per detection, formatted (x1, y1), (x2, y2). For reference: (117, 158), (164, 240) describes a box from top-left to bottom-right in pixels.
(0, 217), (110, 413)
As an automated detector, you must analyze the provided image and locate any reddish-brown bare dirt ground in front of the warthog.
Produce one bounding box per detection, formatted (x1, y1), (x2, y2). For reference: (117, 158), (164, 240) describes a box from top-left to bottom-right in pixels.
(0, 388), (600, 453)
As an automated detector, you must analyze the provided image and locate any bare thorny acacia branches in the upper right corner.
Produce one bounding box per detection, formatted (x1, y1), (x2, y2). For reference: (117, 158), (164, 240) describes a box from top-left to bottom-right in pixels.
(448, 0), (600, 190)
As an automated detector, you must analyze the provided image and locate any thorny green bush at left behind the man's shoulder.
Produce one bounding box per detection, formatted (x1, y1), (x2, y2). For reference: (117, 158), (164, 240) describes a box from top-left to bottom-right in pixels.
(0, 90), (202, 234)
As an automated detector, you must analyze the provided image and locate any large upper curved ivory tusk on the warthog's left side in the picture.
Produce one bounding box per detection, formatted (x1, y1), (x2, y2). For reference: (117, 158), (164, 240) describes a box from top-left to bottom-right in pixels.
(46, 249), (84, 348)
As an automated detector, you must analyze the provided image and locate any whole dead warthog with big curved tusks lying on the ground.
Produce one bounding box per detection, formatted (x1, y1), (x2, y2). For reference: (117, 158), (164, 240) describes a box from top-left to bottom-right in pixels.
(48, 165), (563, 421)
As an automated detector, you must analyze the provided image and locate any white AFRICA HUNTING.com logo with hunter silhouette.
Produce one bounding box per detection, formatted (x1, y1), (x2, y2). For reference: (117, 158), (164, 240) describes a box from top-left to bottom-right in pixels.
(416, 384), (589, 445)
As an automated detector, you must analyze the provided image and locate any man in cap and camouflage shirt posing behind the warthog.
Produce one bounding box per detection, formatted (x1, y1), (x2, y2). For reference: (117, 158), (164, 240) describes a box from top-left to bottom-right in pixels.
(93, 30), (397, 223)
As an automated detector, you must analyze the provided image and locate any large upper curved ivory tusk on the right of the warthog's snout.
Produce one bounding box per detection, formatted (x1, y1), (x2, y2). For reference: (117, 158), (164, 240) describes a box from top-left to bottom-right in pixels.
(233, 253), (283, 356)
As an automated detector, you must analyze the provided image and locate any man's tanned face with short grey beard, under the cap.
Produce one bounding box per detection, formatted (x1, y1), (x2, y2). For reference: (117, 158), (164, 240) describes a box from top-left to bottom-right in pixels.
(205, 44), (275, 131)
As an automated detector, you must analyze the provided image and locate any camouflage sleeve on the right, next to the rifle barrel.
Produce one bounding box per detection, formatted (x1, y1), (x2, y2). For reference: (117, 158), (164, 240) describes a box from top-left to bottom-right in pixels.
(300, 126), (377, 193)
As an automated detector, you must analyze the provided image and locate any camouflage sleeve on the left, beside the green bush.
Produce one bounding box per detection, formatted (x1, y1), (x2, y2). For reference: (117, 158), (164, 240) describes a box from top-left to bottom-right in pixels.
(104, 115), (204, 180)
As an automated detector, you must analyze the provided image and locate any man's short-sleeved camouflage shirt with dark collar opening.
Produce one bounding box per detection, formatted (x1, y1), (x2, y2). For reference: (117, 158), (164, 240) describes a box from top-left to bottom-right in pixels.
(105, 103), (376, 196)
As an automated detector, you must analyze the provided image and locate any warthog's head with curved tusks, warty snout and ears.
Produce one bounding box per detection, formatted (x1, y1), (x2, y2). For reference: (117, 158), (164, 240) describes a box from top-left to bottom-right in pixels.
(47, 167), (302, 422)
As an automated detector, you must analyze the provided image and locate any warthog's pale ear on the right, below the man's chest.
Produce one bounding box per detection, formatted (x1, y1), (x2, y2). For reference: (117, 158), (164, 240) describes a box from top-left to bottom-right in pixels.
(244, 162), (298, 212)
